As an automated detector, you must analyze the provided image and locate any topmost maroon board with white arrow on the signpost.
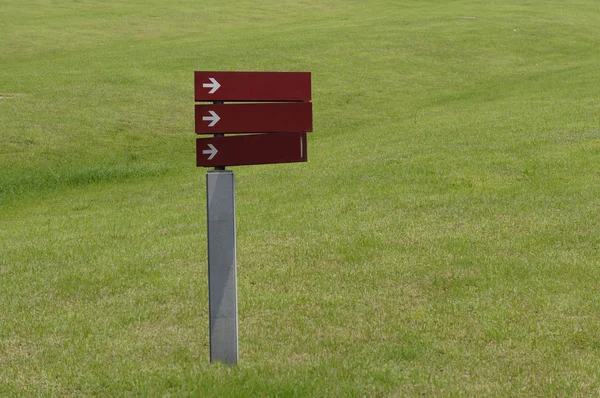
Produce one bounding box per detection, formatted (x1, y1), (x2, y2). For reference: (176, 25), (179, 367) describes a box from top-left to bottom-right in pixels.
(194, 72), (311, 102)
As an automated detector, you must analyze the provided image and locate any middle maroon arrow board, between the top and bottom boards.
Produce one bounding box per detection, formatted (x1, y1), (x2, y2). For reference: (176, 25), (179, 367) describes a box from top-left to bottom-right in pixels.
(196, 102), (312, 134)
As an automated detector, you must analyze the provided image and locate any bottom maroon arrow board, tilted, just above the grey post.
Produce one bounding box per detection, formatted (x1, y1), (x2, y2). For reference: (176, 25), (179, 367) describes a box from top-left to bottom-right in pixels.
(196, 133), (307, 167)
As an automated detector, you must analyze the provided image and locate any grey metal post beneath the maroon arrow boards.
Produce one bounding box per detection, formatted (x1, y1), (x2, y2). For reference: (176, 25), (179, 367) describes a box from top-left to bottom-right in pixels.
(206, 170), (238, 365)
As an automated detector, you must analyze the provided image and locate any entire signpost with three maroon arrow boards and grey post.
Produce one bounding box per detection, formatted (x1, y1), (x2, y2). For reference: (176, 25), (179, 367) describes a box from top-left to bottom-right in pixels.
(194, 72), (312, 365)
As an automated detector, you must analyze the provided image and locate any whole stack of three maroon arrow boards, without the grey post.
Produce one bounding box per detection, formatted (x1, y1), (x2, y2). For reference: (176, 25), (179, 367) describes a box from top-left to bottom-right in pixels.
(194, 71), (312, 168)
